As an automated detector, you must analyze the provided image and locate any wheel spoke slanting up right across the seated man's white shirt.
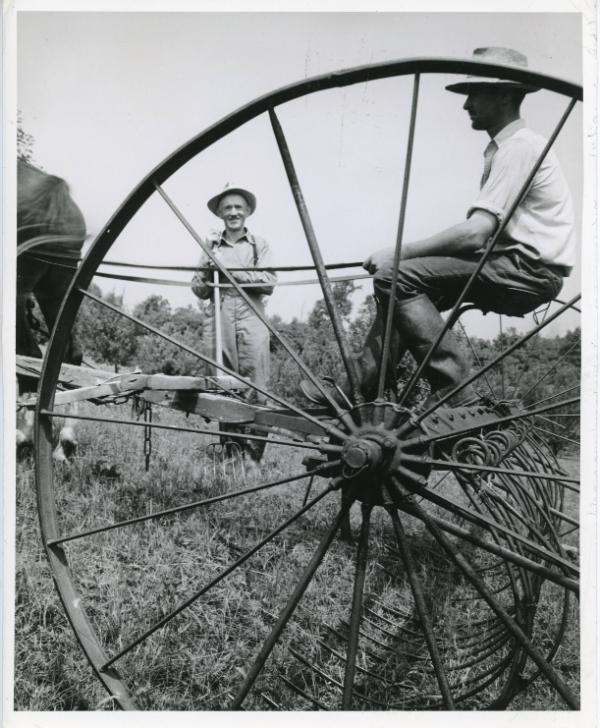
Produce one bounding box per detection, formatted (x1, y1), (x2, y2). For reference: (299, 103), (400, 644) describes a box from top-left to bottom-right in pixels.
(398, 98), (577, 411)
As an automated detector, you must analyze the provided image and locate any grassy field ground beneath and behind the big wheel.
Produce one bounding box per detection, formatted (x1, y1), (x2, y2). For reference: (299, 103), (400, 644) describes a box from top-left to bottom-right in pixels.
(15, 398), (579, 711)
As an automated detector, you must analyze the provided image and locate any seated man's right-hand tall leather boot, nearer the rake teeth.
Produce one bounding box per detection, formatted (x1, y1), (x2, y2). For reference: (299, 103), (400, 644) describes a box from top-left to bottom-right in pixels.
(394, 294), (478, 407)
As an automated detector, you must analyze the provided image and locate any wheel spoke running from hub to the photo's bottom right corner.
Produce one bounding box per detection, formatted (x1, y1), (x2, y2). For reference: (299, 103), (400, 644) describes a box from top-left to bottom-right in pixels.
(396, 483), (579, 710)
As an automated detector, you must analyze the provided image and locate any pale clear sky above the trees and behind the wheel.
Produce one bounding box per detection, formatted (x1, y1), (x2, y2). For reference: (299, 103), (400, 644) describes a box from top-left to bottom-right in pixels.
(17, 12), (580, 335)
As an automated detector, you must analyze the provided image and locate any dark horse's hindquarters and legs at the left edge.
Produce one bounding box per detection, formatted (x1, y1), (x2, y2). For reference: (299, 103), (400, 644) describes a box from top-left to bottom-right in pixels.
(15, 159), (86, 461)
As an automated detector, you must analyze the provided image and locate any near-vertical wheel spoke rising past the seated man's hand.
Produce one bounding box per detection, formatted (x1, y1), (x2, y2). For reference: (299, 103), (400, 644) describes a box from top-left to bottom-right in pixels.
(377, 73), (421, 399)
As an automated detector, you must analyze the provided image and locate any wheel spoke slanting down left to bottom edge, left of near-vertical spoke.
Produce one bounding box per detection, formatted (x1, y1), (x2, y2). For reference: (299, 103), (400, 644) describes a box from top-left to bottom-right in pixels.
(231, 492), (352, 710)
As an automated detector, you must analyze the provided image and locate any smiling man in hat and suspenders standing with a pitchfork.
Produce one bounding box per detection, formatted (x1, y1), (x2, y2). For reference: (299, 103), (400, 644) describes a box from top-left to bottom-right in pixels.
(192, 185), (277, 461)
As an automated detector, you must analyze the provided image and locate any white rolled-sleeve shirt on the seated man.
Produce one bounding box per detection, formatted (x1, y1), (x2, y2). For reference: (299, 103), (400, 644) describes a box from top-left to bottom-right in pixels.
(467, 119), (576, 269)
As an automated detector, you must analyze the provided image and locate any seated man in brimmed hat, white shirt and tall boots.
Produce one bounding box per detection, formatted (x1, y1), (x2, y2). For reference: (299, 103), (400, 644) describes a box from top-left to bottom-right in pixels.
(302, 48), (575, 407)
